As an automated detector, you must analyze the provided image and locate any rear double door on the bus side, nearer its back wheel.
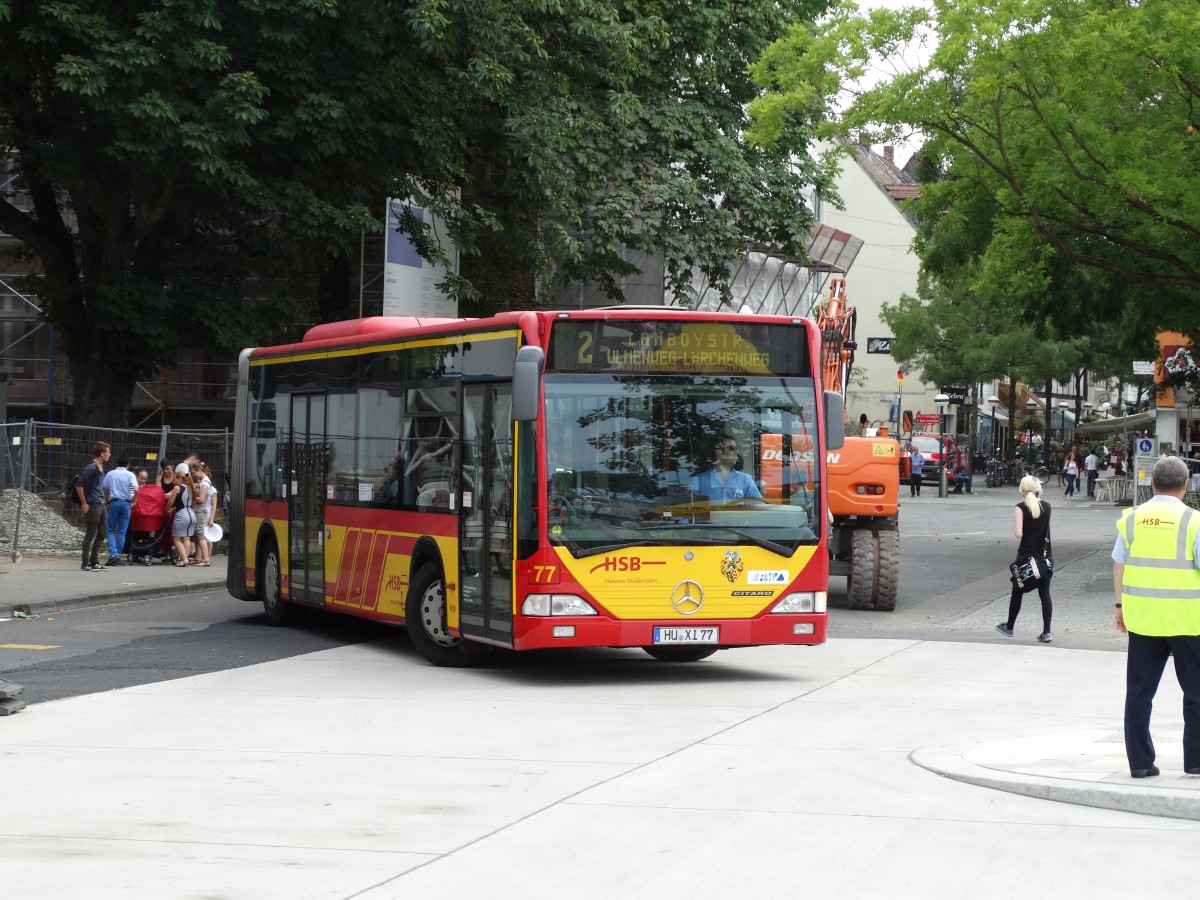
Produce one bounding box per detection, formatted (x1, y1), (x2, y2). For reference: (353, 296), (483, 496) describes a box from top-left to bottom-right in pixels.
(288, 394), (329, 604)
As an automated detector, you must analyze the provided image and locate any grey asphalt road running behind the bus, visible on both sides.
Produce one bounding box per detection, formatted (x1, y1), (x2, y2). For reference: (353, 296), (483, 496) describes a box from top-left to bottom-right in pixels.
(0, 486), (1124, 703)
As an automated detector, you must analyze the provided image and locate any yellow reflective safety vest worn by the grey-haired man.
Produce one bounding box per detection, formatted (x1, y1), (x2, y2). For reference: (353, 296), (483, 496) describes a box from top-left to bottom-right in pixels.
(1117, 498), (1200, 637)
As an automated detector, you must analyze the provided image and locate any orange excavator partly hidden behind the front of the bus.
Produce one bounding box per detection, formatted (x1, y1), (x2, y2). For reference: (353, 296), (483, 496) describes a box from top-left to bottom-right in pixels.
(816, 278), (900, 612)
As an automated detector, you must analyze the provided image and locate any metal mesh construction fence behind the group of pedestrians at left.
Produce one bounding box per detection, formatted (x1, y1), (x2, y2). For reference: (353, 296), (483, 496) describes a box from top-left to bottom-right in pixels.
(0, 420), (232, 562)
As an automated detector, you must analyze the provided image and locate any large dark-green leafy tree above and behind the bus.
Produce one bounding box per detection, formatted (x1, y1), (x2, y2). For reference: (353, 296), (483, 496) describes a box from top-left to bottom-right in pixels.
(0, 0), (826, 424)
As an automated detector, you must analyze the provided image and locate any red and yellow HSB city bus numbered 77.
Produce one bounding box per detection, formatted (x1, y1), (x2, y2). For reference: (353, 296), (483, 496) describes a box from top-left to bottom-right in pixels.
(229, 307), (844, 665)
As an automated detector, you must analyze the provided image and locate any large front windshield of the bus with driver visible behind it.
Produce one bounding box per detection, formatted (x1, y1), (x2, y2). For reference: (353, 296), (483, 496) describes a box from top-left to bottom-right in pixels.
(545, 373), (823, 557)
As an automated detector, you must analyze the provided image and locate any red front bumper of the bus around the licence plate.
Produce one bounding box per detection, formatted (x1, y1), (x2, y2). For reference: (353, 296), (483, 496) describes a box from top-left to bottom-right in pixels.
(514, 613), (829, 650)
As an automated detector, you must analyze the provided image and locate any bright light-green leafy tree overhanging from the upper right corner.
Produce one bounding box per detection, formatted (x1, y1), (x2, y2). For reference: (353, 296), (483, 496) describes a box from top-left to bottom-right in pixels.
(754, 0), (1200, 341)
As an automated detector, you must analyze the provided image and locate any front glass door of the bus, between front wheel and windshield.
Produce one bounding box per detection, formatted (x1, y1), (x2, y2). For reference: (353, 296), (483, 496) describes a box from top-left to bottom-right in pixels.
(458, 384), (516, 647)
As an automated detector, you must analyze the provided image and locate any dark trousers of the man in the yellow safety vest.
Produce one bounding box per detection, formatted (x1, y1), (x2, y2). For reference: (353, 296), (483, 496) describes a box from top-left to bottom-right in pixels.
(1126, 631), (1200, 769)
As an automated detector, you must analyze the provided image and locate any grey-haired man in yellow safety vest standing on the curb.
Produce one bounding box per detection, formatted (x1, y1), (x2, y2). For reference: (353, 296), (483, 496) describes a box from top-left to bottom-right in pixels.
(1112, 456), (1200, 778)
